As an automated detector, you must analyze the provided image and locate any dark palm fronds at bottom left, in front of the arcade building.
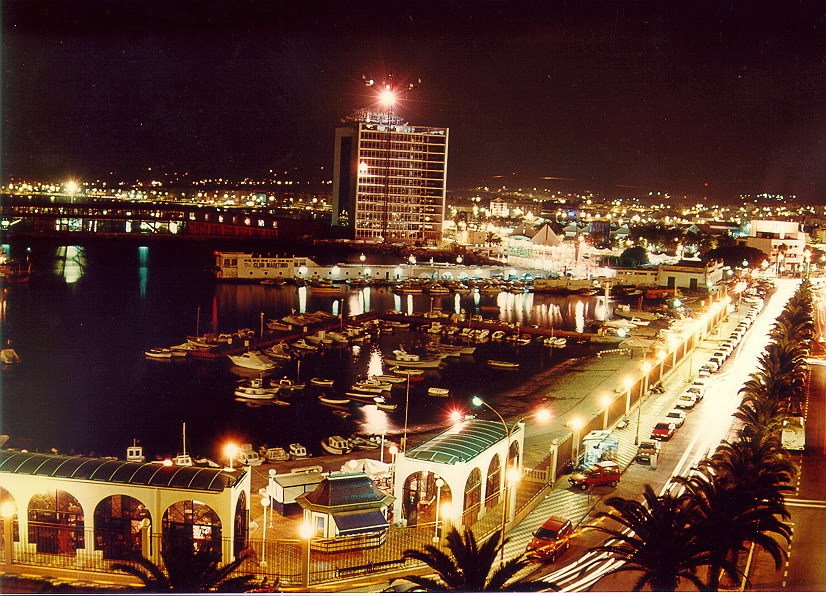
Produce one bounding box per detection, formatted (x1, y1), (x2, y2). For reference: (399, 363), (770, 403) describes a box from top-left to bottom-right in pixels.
(112, 545), (255, 592)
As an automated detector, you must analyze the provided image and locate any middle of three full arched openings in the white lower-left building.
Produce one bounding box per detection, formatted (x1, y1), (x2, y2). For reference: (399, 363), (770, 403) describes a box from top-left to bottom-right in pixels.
(95, 495), (152, 560)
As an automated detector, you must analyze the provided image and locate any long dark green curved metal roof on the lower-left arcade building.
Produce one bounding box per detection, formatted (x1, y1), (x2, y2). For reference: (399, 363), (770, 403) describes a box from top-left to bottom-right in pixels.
(0, 450), (244, 492)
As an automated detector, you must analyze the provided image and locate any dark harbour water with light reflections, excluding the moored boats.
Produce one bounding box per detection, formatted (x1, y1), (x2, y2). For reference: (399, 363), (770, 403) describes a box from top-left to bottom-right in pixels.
(0, 242), (601, 459)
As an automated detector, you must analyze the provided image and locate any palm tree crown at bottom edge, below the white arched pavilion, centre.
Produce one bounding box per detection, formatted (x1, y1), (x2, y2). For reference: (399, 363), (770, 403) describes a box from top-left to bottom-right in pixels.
(404, 528), (557, 592)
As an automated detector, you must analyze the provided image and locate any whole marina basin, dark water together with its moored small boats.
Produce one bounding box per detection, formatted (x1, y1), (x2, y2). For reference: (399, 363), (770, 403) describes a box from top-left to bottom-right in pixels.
(3, 244), (696, 460)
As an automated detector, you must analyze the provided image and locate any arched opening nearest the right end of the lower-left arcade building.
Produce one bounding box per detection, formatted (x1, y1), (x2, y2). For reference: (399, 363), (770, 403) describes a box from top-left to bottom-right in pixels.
(161, 501), (221, 557)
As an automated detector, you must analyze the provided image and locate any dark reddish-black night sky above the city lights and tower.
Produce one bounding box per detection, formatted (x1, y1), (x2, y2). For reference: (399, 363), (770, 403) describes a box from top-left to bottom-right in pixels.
(2, 0), (826, 203)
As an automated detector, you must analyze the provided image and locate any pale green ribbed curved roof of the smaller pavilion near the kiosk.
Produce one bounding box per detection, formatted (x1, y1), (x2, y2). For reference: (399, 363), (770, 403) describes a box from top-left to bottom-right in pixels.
(406, 420), (508, 465)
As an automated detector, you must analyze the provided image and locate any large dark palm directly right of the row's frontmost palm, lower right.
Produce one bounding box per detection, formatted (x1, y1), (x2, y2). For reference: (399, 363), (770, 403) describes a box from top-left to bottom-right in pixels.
(674, 466), (791, 592)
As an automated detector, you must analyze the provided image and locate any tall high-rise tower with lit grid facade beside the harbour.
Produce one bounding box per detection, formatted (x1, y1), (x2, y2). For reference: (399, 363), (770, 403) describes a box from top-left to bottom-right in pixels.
(333, 108), (448, 242)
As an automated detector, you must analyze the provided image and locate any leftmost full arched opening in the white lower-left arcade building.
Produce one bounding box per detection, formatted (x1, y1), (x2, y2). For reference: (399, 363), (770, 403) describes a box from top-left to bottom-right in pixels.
(28, 490), (84, 556)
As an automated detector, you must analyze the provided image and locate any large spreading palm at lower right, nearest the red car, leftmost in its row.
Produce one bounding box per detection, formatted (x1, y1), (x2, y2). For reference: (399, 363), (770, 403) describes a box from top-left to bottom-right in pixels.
(589, 485), (712, 592)
